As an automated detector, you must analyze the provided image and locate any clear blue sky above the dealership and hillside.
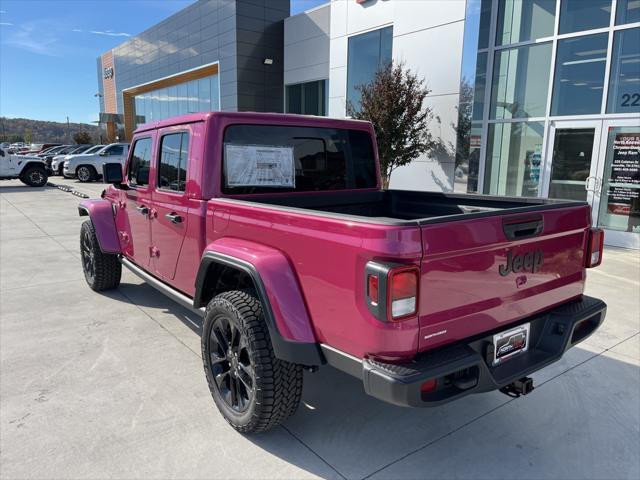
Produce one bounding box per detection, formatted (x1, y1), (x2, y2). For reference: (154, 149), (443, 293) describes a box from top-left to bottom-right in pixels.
(0, 0), (328, 123)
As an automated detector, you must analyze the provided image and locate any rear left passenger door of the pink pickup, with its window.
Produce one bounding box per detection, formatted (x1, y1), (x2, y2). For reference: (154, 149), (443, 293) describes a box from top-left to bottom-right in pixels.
(151, 129), (191, 280)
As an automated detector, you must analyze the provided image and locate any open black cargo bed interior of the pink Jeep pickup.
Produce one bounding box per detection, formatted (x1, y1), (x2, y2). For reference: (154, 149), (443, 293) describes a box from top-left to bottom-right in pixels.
(220, 190), (581, 226)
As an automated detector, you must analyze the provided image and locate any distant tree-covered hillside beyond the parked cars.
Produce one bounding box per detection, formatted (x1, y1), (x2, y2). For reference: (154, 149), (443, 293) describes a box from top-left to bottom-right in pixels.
(0, 117), (100, 143)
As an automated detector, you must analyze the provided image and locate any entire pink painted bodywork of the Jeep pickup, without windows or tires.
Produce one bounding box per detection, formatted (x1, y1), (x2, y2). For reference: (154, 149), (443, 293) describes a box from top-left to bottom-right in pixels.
(92, 113), (604, 361)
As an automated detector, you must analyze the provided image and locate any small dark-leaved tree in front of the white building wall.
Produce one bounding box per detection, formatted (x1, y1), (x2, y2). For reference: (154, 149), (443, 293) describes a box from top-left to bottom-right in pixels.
(347, 63), (434, 189)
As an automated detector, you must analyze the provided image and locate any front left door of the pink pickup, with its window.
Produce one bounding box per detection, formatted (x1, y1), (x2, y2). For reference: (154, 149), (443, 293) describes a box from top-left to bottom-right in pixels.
(116, 134), (154, 267)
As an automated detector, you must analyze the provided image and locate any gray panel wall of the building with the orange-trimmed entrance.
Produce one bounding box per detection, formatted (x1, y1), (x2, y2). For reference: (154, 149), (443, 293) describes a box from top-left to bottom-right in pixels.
(98, 0), (289, 113)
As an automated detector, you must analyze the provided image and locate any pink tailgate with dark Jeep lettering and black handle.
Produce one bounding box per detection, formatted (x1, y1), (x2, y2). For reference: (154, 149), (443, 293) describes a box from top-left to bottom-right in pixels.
(418, 204), (590, 351)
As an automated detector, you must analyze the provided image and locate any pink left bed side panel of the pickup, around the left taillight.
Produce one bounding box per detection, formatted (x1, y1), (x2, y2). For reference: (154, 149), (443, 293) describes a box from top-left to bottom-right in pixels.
(207, 199), (422, 358)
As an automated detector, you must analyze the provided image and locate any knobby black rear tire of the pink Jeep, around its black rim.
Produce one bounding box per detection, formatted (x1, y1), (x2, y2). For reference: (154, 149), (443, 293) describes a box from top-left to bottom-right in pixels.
(201, 290), (302, 433)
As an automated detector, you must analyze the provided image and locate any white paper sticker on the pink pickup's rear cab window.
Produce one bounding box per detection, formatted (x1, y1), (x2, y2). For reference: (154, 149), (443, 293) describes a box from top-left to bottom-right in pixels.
(224, 143), (296, 188)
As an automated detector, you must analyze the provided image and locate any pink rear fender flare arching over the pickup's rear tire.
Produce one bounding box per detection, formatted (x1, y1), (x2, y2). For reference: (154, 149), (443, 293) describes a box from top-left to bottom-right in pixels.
(205, 237), (316, 343)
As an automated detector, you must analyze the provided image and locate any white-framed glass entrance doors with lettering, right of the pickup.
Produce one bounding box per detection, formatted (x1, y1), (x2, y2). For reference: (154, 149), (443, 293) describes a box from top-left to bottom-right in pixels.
(540, 120), (640, 249)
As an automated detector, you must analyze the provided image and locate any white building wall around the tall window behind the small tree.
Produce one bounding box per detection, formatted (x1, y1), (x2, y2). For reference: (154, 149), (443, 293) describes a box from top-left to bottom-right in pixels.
(284, 0), (466, 191)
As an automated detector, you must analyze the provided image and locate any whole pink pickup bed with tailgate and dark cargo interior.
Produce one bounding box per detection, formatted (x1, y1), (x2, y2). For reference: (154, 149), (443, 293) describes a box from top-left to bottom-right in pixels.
(209, 190), (590, 358)
